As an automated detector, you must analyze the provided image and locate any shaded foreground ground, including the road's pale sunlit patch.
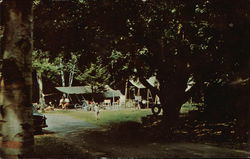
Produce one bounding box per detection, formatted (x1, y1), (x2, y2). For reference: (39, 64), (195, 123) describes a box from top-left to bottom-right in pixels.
(32, 114), (250, 158)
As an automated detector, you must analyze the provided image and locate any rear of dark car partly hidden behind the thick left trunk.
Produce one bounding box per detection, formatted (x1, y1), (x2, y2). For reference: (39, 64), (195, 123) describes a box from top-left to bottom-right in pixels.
(33, 106), (48, 133)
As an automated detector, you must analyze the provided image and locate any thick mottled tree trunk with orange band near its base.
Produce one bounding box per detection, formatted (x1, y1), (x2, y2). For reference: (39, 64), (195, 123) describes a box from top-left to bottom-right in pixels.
(0, 0), (34, 158)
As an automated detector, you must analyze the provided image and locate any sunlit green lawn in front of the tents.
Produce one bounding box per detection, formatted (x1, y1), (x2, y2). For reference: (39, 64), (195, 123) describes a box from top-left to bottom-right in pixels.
(45, 109), (152, 126)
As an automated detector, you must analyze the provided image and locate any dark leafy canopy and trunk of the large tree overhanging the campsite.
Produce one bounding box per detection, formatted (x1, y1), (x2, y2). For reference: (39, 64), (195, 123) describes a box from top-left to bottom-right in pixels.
(34, 0), (250, 120)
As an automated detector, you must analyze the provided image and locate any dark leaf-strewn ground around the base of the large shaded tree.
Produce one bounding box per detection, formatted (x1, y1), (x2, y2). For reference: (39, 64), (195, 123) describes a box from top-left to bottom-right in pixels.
(143, 116), (250, 150)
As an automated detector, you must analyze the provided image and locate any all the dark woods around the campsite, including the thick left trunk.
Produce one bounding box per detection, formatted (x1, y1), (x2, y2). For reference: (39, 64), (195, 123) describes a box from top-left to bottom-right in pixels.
(0, 0), (250, 158)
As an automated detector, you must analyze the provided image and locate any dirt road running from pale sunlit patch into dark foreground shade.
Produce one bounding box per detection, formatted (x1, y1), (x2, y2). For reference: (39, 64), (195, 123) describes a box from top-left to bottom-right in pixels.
(43, 114), (250, 158)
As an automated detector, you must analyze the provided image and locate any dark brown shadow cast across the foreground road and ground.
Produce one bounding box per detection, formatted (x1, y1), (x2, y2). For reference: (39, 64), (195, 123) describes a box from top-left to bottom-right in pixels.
(67, 122), (250, 158)
